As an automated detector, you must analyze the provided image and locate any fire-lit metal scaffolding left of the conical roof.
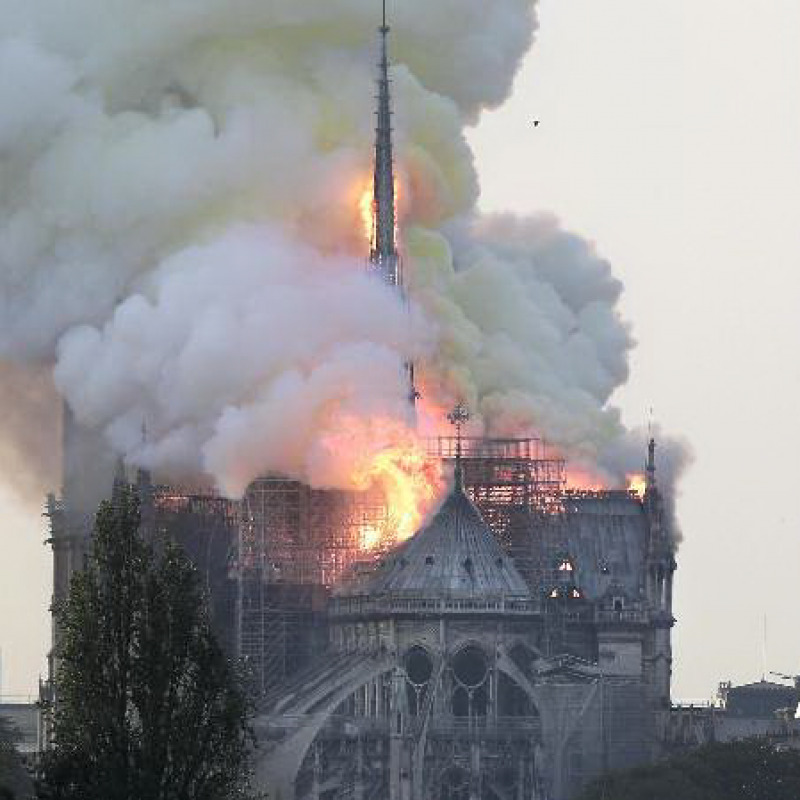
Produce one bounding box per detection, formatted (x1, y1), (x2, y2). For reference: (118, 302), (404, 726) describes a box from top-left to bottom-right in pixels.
(237, 478), (387, 693)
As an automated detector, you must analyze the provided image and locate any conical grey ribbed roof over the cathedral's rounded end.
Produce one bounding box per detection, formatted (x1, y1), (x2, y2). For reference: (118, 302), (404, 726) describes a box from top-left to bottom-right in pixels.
(348, 481), (530, 598)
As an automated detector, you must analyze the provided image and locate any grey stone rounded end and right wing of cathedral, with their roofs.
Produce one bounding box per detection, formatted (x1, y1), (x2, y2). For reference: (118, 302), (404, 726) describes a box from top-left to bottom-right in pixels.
(252, 445), (675, 800)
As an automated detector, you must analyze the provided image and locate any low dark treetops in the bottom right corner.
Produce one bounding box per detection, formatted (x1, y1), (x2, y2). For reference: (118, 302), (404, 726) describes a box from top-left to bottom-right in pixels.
(578, 739), (800, 800)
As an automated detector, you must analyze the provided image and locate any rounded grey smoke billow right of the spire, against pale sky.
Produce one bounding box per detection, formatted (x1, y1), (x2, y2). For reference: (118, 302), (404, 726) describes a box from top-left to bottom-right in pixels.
(412, 212), (631, 459)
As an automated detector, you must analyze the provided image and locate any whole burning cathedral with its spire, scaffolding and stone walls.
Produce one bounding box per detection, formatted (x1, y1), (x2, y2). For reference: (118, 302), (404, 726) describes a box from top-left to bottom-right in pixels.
(43, 6), (676, 800)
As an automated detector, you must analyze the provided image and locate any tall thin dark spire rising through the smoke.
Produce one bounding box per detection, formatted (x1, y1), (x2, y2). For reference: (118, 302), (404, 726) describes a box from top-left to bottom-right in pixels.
(369, 0), (402, 288)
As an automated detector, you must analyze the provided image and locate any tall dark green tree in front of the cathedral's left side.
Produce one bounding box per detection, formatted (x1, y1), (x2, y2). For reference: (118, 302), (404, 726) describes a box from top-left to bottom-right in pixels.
(41, 486), (252, 800)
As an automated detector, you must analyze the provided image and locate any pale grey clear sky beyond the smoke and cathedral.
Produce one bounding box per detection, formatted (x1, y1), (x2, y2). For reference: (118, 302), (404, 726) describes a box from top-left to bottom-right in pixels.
(0, 0), (800, 698)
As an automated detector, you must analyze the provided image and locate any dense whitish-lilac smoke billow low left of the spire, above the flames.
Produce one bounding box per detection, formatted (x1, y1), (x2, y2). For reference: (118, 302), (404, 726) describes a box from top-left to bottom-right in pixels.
(55, 227), (434, 494)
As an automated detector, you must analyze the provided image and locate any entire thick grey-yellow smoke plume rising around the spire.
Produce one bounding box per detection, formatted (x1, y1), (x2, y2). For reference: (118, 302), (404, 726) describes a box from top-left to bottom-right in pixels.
(0, 0), (688, 520)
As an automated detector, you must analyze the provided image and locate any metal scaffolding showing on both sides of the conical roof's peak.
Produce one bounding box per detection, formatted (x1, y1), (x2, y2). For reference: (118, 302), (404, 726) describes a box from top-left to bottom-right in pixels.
(230, 437), (566, 693)
